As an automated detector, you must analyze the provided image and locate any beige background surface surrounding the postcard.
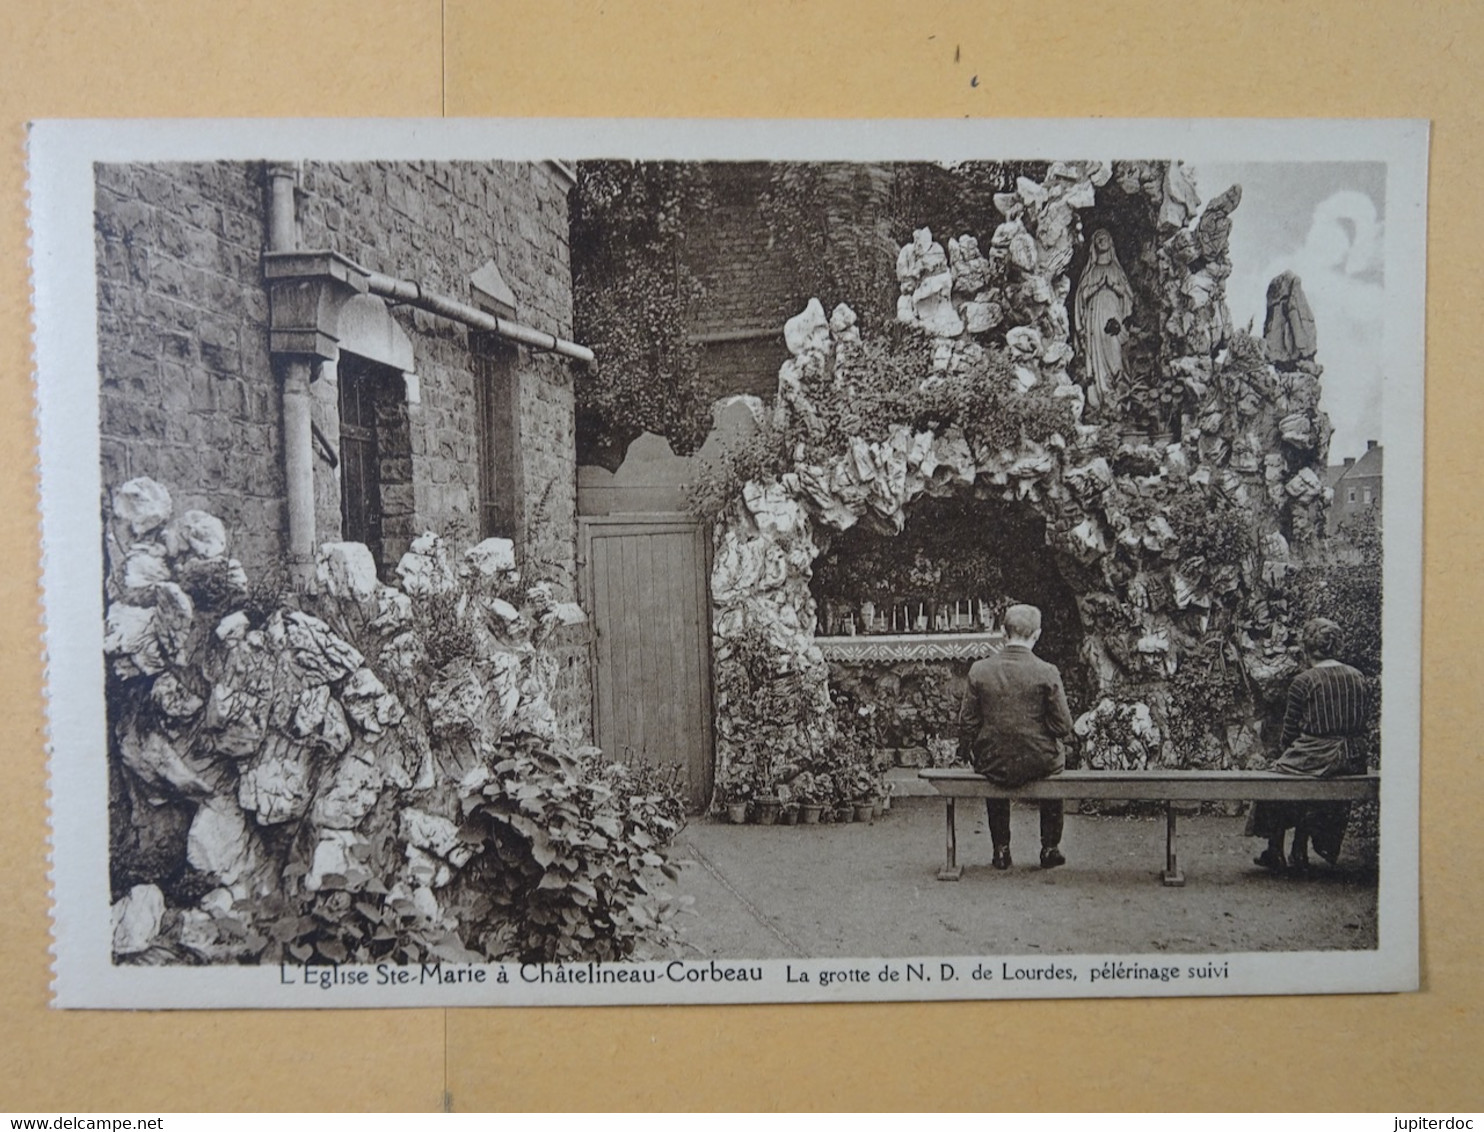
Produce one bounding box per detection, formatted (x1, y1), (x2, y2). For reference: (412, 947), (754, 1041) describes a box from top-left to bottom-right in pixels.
(0, 0), (1484, 1111)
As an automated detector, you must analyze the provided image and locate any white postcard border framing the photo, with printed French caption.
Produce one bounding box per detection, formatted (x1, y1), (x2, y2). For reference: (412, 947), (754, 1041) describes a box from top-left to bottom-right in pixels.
(30, 119), (1428, 1007)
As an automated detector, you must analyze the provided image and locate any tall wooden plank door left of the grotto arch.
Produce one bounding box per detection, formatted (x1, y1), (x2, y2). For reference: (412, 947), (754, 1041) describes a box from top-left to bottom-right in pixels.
(580, 516), (712, 807)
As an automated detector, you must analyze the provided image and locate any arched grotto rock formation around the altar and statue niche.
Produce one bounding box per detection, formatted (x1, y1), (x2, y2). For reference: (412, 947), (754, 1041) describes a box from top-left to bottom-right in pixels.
(712, 162), (1330, 794)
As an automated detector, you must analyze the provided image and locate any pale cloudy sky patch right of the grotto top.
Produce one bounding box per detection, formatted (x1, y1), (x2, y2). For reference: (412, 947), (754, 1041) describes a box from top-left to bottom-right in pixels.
(1187, 162), (1386, 464)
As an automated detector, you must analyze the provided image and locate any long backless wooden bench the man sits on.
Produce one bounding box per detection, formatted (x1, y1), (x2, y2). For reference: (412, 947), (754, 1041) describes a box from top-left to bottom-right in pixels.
(917, 767), (1382, 887)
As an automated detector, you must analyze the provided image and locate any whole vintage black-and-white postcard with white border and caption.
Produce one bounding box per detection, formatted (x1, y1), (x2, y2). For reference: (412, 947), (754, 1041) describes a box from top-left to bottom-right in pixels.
(30, 120), (1428, 1007)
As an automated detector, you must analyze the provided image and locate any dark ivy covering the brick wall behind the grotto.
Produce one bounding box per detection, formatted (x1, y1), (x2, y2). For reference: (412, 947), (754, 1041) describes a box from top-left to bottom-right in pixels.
(571, 160), (1046, 470)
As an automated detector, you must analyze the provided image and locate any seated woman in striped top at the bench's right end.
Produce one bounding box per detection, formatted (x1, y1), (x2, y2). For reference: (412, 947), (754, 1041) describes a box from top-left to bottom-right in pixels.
(1247, 617), (1370, 872)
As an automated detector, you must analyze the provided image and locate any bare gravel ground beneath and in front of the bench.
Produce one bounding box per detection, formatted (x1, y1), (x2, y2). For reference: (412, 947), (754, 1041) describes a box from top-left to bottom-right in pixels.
(675, 798), (1377, 958)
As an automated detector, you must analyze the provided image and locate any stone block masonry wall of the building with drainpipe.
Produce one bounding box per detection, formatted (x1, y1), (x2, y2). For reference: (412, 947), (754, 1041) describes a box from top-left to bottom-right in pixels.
(95, 162), (588, 744)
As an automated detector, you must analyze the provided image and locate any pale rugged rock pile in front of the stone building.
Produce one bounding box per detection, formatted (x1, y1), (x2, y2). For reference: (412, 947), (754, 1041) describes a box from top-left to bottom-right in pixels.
(104, 479), (582, 961)
